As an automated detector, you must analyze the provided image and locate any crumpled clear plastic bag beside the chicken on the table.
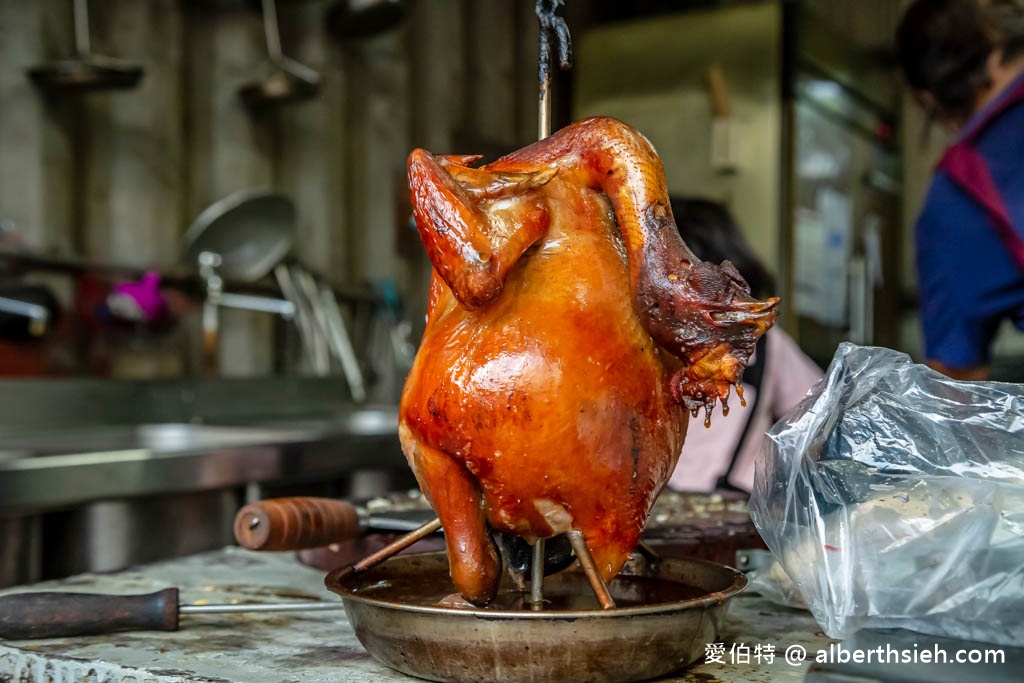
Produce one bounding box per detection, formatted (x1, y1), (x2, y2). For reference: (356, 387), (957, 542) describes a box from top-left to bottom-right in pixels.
(751, 344), (1024, 645)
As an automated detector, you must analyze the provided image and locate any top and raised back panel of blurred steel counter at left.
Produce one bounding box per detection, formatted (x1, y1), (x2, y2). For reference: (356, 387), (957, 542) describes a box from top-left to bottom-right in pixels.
(0, 377), (406, 517)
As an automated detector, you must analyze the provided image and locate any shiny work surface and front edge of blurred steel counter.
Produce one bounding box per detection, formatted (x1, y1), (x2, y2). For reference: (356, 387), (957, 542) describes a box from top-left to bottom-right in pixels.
(0, 407), (406, 514)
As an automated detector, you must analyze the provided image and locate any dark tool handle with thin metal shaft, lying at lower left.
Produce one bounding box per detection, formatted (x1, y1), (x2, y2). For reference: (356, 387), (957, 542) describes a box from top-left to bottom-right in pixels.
(0, 588), (178, 640)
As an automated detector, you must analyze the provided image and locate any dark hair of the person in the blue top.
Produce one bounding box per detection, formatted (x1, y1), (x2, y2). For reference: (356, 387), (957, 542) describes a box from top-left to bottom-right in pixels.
(896, 0), (1024, 120)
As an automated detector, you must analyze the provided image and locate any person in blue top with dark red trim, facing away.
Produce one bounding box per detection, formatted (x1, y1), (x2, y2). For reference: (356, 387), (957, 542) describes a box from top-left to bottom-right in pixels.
(896, 0), (1024, 380)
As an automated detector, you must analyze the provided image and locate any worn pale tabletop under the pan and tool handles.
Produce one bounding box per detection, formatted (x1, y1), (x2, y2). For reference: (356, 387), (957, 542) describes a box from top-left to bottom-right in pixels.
(0, 548), (830, 683)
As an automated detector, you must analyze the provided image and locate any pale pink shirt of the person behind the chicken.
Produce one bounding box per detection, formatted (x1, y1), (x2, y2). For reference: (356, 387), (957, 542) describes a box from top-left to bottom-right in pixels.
(669, 329), (822, 493)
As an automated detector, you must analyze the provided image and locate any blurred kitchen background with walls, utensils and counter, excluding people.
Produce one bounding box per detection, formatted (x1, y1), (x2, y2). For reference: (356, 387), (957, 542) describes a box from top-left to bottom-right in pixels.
(0, 0), (1024, 587)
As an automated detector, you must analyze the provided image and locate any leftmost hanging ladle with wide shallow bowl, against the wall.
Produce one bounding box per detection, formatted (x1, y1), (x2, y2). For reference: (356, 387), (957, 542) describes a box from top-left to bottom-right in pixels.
(29, 0), (142, 91)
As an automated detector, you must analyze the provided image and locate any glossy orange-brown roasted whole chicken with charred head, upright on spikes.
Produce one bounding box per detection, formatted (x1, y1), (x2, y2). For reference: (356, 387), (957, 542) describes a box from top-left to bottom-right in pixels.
(399, 118), (778, 604)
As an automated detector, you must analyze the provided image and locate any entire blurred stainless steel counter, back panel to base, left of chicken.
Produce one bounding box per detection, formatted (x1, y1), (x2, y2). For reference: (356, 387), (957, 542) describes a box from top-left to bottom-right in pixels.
(0, 377), (412, 587)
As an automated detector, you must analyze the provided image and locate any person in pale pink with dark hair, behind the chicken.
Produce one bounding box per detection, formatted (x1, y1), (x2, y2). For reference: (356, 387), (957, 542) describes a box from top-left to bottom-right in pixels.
(669, 199), (822, 493)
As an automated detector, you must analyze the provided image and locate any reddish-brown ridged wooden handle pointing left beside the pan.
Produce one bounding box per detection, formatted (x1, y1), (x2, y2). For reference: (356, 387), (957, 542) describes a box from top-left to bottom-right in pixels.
(234, 498), (362, 551)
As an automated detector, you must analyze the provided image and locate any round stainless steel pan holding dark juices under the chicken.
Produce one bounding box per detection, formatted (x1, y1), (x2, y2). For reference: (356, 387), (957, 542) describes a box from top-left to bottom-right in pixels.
(326, 553), (746, 681)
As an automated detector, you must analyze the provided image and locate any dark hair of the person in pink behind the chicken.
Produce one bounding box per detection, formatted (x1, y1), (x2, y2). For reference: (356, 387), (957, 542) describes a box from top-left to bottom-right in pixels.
(671, 197), (775, 297)
